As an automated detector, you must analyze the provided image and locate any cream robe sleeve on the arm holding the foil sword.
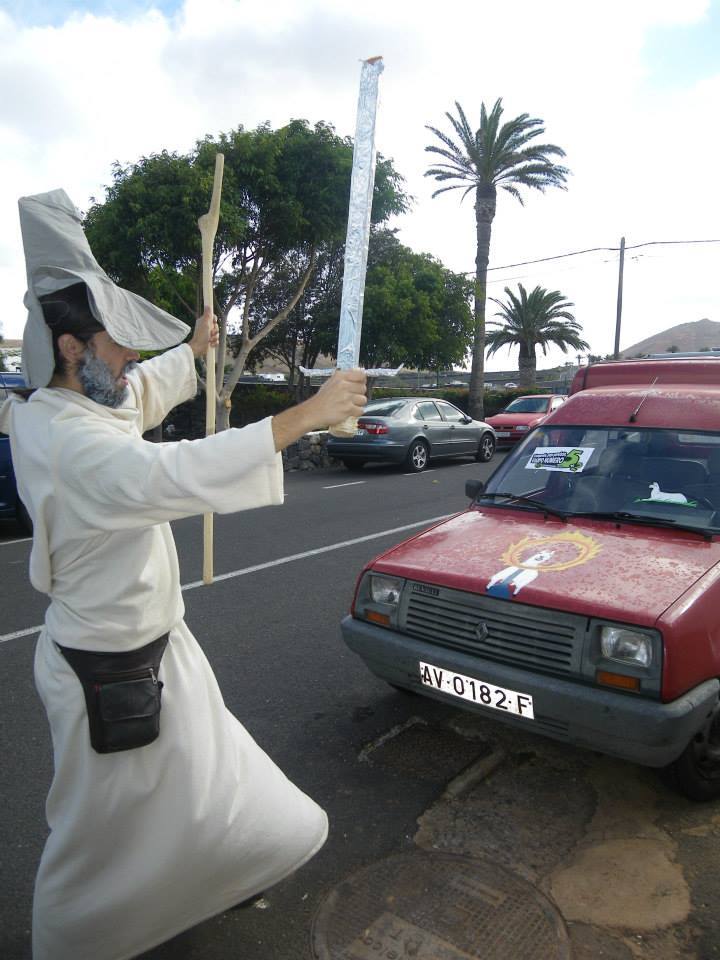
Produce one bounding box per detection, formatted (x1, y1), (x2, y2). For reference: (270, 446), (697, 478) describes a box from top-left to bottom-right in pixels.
(51, 417), (283, 532)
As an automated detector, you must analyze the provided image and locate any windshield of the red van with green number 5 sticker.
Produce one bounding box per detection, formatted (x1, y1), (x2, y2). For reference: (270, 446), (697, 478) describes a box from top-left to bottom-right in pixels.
(478, 425), (720, 531)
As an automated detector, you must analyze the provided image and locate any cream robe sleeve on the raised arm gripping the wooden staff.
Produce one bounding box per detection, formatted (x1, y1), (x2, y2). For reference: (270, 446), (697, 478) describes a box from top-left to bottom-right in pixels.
(128, 343), (197, 433)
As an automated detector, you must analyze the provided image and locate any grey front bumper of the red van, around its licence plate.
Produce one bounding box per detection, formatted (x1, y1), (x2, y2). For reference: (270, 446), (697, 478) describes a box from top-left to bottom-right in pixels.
(341, 616), (720, 767)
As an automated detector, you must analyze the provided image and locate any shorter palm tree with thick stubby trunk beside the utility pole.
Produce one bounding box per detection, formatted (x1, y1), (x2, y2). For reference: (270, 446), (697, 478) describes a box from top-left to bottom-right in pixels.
(486, 283), (590, 388)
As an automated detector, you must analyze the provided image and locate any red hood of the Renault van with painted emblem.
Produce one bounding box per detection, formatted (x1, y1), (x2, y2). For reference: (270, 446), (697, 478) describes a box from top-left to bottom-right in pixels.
(371, 507), (720, 626)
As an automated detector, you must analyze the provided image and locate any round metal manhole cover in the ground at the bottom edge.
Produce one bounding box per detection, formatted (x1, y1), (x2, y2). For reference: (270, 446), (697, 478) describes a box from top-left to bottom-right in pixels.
(312, 851), (570, 960)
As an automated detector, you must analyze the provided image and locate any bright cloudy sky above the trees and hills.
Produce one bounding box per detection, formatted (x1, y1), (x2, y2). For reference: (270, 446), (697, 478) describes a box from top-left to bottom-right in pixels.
(0, 0), (720, 369)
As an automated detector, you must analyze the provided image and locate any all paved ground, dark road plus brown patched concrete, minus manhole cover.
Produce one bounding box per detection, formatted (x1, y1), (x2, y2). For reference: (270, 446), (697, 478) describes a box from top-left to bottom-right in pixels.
(0, 457), (720, 960)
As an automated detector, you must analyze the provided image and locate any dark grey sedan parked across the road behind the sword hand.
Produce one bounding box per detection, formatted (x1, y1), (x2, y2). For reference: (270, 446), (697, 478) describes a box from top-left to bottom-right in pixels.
(327, 397), (495, 473)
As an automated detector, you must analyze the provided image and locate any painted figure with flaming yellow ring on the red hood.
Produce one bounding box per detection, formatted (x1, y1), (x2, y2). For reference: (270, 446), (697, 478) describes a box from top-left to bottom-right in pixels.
(485, 531), (600, 600)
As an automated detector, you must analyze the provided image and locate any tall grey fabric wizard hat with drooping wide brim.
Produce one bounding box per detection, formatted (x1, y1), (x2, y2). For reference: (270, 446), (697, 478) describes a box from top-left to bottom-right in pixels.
(18, 190), (190, 387)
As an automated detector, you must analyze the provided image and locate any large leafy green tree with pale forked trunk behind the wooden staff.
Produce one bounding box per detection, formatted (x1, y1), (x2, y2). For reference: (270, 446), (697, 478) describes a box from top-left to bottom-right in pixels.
(85, 120), (407, 429)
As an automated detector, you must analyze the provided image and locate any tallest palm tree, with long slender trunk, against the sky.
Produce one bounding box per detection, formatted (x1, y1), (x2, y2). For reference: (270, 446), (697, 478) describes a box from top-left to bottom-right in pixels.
(425, 99), (570, 419)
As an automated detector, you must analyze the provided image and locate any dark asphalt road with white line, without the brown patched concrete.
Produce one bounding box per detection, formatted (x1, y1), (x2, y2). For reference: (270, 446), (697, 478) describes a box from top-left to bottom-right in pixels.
(0, 455), (501, 960)
